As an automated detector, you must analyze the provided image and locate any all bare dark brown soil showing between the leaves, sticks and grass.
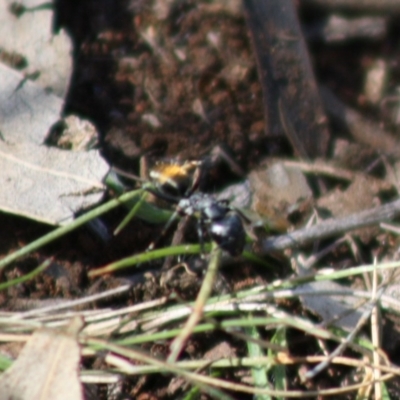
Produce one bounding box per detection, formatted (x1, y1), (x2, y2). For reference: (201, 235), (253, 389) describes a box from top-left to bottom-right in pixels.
(0, 0), (399, 399)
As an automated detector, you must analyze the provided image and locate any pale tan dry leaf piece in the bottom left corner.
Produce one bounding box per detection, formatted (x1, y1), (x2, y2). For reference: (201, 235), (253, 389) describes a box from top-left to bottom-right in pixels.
(0, 319), (83, 400)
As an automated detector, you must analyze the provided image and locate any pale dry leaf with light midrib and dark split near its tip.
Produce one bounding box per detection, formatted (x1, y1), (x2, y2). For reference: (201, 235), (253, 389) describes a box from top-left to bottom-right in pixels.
(0, 142), (109, 225)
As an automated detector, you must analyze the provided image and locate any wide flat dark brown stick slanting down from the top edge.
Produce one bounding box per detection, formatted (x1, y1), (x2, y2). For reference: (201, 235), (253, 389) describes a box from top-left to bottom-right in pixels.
(243, 0), (329, 158)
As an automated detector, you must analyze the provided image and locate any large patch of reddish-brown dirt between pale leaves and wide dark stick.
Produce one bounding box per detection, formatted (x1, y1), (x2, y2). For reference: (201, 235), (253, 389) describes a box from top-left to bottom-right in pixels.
(61, 2), (269, 172)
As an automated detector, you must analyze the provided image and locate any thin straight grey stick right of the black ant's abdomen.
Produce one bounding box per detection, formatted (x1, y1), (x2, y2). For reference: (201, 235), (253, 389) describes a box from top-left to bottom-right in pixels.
(262, 200), (400, 253)
